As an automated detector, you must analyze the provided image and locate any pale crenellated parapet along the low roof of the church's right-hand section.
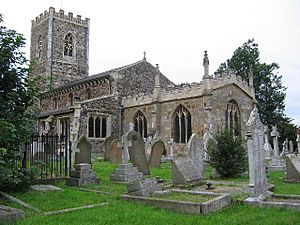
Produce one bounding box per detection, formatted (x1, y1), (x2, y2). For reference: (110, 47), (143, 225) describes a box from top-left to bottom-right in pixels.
(122, 71), (255, 108)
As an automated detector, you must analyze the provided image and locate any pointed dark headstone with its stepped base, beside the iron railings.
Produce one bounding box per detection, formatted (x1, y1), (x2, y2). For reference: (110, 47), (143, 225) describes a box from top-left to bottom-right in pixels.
(66, 135), (99, 187)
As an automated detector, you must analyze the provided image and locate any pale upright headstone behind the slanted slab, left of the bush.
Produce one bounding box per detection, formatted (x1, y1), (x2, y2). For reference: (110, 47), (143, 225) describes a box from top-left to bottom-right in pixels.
(187, 134), (204, 177)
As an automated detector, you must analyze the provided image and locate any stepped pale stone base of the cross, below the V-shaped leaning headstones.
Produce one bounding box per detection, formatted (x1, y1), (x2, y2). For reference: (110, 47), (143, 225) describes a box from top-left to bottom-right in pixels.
(110, 163), (143, 183)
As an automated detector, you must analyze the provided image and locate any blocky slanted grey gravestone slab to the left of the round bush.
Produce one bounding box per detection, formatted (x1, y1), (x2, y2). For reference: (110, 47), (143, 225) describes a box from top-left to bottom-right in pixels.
(172, 158), (202, 185)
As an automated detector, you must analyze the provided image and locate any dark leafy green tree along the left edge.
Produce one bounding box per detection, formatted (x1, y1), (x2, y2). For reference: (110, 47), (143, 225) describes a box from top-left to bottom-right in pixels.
(0, 15), (37, 190)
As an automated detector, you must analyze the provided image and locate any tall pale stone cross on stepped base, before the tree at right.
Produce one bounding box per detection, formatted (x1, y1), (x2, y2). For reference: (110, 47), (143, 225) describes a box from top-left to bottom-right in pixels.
(270, 126), (285, 170)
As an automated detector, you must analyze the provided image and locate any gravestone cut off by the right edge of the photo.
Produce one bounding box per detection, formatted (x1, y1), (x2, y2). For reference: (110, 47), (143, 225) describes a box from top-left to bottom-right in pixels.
(285, 154), (300, 182)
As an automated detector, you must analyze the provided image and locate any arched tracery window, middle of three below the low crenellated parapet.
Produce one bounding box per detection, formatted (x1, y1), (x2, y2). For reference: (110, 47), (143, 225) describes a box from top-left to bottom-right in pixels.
(173, 105), (192, 143)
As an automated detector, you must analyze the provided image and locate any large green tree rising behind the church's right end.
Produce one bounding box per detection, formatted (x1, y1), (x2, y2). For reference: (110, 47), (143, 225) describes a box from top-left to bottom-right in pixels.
(216, 39), (296, 139)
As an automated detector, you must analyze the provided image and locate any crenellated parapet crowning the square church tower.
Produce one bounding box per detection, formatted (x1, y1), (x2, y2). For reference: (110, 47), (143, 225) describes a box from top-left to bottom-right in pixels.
(31, 7), (90, 28)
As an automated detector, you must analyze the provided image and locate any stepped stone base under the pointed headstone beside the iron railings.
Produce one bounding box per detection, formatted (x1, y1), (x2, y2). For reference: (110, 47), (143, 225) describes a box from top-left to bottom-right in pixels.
(66, 163), (100, 187)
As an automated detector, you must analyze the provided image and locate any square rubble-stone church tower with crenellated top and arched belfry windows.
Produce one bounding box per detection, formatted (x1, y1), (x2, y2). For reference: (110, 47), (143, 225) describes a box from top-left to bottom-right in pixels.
(29, 7), (90, 91)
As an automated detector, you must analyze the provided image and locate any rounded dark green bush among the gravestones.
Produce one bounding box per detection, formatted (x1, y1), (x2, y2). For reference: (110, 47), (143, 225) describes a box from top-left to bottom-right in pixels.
(208, 130), (247, 177)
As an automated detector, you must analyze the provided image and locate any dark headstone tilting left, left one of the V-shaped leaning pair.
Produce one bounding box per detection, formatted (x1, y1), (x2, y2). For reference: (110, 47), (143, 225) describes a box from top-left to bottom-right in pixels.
(126, 131), (150, 175)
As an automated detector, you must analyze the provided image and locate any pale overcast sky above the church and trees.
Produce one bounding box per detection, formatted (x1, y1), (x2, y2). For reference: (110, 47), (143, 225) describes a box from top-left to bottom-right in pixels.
(0, 0), (300, 126)
